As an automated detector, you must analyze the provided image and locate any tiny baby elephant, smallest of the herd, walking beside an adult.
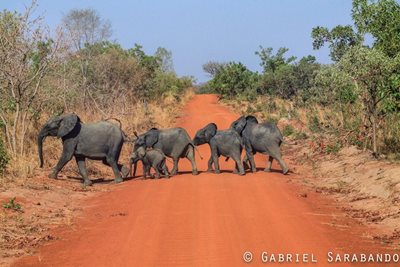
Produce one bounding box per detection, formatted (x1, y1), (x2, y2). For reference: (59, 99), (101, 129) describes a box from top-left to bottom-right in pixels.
(130, 147), (169, 178)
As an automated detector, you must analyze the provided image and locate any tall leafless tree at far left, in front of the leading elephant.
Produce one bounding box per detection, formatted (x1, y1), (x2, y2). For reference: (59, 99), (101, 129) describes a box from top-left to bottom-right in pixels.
(0, 1), (60, 157)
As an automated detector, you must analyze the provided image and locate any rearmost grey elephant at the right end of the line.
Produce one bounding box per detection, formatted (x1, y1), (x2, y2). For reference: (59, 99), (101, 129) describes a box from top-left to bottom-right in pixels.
(231, 115), (289, 174)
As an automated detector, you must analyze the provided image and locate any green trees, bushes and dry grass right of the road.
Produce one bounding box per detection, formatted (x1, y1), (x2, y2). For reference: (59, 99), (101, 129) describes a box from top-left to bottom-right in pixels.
(200, 0), (400, 160)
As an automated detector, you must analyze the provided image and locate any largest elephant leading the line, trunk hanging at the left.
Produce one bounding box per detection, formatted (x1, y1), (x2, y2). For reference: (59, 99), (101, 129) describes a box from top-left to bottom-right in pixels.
(37, 113), (129, 185)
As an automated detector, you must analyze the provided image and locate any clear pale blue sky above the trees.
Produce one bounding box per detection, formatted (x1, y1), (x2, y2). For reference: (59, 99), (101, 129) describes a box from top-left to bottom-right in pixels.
(0, 0), (351, 82)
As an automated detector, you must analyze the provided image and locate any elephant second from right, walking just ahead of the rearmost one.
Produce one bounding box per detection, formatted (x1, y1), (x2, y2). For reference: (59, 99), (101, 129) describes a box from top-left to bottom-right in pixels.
(193, 123), (244, 175)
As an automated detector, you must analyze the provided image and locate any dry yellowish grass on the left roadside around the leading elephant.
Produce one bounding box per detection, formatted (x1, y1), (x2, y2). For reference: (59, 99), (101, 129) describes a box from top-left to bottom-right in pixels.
(0, 89), (194, 189)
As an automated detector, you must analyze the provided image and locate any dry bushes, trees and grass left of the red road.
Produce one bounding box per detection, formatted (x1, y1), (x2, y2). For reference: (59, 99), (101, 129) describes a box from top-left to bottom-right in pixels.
(0, 1), (193, 182)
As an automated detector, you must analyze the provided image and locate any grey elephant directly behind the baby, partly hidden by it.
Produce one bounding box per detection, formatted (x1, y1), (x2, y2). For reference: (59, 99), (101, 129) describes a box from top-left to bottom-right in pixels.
(134, 127), (198, 175)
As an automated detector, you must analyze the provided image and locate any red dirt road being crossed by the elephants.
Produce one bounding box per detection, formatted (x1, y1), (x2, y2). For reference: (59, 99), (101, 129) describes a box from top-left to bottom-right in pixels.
(14, 95), (394, 266)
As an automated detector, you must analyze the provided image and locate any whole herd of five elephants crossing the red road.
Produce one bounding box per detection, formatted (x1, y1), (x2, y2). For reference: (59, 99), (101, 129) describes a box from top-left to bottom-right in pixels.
(37, 114), (289, 185)
